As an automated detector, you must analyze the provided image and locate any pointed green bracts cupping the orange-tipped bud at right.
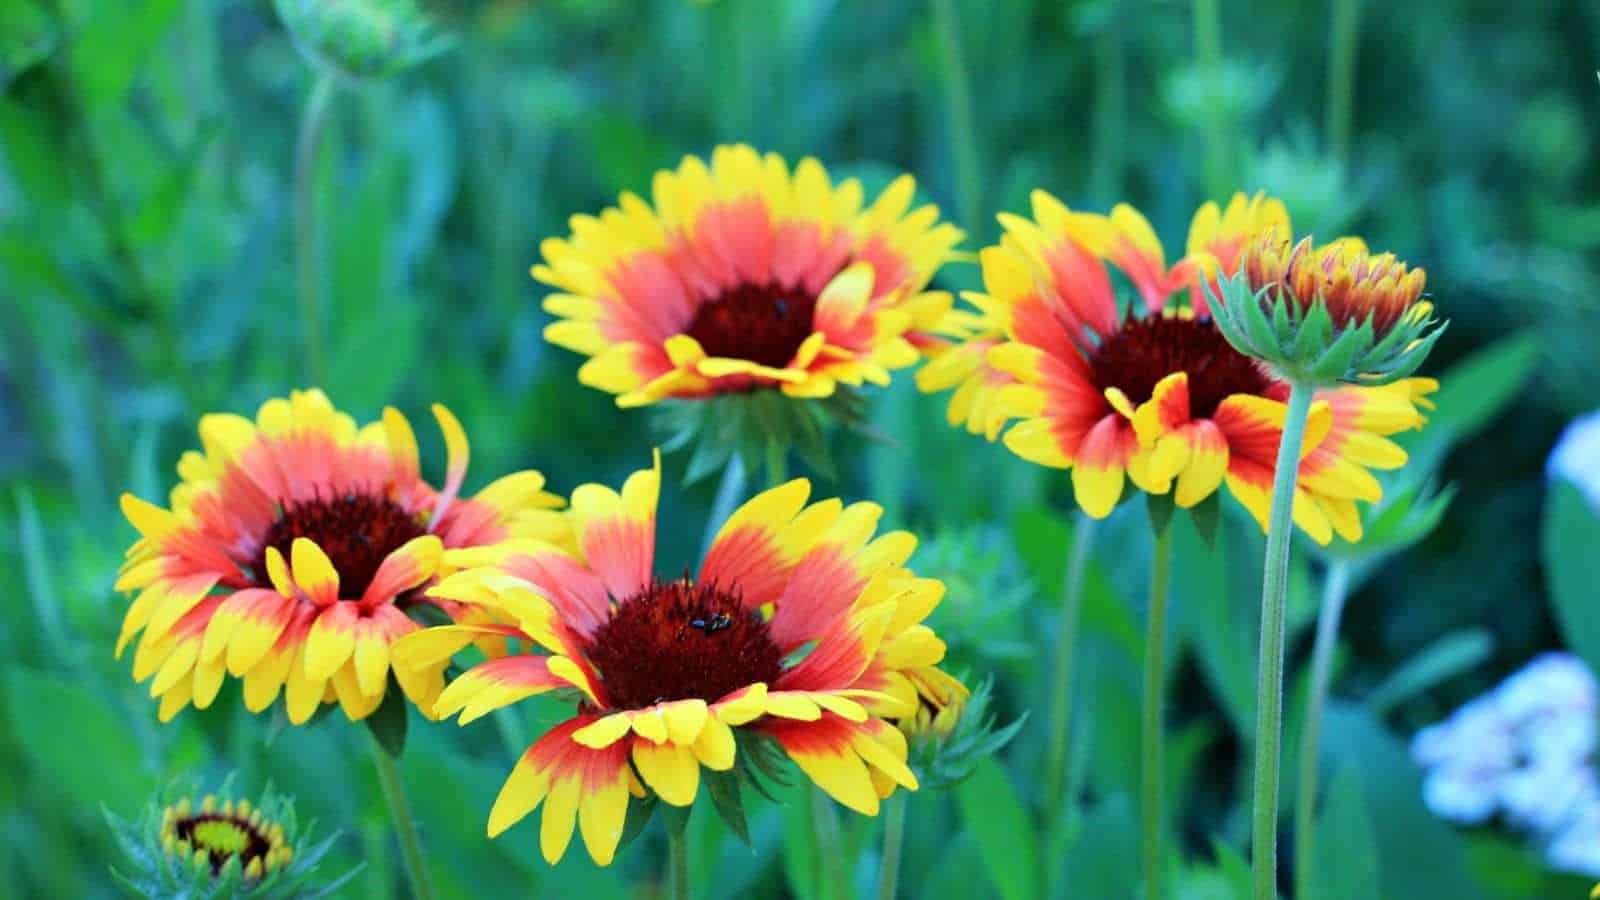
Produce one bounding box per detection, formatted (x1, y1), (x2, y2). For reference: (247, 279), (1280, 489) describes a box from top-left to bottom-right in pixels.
(1206, 271), (1446, 386)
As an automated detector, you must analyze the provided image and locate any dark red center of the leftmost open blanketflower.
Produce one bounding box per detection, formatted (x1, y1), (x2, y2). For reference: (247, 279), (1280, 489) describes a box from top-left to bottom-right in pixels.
(251, 493), (427, 597)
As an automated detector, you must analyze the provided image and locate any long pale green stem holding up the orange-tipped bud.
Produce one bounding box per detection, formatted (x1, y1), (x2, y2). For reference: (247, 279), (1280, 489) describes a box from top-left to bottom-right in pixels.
(1251, 381), (1314, 900)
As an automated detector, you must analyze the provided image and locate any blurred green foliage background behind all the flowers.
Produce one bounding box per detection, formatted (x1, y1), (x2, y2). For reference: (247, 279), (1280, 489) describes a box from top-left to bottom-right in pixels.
(0, 0), (1600, 900)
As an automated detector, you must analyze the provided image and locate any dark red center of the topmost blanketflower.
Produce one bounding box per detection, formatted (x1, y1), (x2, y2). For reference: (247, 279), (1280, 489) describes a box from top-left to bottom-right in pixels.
(685, 277), (816, 368)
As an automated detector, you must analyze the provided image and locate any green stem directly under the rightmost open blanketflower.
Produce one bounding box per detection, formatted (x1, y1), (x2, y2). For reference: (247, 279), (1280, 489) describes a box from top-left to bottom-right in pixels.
(1139, 527), (1173, 900)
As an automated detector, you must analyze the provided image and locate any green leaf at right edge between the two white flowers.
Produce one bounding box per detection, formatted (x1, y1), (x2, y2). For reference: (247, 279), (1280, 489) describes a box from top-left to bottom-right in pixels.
(1541, 479), (1600, 671)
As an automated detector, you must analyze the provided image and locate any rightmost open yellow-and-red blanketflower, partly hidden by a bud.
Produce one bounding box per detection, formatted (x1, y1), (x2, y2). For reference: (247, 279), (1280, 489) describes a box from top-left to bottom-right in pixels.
(930, 192), (1437, 543)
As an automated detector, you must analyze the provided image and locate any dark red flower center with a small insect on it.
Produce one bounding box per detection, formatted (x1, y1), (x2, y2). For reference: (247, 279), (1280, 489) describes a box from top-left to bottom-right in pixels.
(587, 578), (782, 709)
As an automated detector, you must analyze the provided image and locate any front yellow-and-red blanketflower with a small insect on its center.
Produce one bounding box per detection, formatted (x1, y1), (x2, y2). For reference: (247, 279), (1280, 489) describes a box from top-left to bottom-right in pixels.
(395, 451), (944, 865)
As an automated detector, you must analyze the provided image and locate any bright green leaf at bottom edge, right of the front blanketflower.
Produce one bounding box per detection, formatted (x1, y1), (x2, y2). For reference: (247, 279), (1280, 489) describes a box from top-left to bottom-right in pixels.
(955, 759), (1038, 900)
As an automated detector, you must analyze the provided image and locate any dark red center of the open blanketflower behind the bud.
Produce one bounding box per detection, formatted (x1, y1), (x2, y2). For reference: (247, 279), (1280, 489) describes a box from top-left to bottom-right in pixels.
(1090, 314), (1272, 418)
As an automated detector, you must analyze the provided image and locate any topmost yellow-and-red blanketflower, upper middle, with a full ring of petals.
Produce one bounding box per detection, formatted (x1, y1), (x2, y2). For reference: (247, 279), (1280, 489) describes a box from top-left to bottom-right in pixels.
(533, 144), (962, 407)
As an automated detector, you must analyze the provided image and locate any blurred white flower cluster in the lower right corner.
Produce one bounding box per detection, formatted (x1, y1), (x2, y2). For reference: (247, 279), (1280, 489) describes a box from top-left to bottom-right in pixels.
(1411, 650), (1600, 878)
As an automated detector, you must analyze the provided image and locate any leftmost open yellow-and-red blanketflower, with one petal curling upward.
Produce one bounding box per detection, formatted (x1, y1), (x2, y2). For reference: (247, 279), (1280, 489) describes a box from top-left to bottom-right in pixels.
(117, 391), (568, 724)
